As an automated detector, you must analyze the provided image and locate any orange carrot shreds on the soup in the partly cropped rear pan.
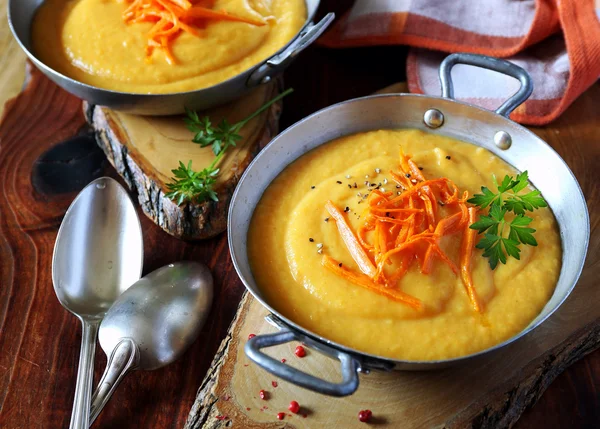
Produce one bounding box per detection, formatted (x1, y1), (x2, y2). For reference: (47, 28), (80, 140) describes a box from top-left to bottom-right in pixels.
(122, 0), (265, 64)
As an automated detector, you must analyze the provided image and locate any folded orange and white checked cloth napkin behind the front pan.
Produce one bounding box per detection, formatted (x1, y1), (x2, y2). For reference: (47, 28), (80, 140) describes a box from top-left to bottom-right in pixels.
(320, 0), (600, 125)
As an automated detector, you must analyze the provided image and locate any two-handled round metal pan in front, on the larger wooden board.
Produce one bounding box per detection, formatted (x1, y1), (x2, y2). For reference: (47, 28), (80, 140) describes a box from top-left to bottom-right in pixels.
(227, 54), (590, 396)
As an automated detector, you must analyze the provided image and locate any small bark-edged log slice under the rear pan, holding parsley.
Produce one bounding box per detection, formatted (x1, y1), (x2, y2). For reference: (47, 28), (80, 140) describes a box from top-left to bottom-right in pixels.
(83, 82), (281, 240)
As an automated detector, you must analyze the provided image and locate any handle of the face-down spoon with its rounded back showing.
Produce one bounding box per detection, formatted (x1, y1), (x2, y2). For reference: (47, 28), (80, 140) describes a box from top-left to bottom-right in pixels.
(90, 338), (140, 426)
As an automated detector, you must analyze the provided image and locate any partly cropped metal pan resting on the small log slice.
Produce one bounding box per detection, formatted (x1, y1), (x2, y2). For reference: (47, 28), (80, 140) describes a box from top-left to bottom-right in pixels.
(8, 0), (335, 115)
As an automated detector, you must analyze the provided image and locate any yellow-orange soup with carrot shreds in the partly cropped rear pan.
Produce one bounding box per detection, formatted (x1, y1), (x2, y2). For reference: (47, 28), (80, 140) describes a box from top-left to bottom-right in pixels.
(32, 0), (307, 93)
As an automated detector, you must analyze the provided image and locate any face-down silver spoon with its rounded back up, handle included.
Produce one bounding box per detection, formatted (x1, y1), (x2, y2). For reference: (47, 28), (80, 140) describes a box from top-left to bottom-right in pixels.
(90, 262), (213, 425)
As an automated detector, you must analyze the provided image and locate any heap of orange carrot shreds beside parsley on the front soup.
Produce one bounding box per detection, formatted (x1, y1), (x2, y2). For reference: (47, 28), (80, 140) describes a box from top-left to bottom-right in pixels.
(322, 150), (481, 312)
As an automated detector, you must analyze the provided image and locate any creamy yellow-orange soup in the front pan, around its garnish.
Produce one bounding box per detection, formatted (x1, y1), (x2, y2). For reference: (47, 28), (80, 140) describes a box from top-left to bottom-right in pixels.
(248, 130), (562, 361)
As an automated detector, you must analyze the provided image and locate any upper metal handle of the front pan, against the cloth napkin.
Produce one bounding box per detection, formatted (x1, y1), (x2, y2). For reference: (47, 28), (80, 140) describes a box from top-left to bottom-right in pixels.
(440, 53), (533, 118)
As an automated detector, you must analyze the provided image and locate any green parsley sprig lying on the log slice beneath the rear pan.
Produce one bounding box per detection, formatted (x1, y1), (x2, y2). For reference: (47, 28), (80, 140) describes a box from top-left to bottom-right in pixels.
(166, 88), (294, 205)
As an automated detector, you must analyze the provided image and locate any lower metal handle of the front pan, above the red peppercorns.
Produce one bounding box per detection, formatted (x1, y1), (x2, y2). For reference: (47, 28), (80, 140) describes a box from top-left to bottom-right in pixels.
(244, 330), (360, 396)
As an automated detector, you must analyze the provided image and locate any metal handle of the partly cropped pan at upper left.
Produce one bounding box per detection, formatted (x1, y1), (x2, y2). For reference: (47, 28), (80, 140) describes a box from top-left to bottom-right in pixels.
(246, 12), (335, 87)
